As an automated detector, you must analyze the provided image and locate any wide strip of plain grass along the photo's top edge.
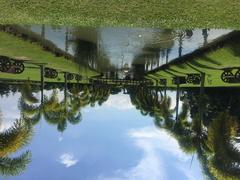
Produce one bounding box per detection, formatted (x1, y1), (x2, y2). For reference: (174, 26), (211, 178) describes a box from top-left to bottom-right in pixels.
(0, 0), (240, 29)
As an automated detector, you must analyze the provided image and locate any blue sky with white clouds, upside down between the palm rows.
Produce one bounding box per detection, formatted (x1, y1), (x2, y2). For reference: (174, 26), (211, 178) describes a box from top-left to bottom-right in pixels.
(0, 93), (203, 180)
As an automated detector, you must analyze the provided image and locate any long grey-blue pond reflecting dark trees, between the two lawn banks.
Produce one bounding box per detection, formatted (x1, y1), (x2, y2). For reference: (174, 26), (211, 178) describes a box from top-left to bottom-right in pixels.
(19, 25), (230, 70)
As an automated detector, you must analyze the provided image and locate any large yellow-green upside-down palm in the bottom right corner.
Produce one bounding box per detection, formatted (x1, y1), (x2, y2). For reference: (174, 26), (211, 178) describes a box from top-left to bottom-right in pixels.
(207, 111), (240, 179)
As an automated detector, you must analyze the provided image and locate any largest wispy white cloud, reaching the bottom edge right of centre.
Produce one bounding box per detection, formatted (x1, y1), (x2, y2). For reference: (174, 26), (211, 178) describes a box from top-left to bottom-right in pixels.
(98, 126), (189, 180)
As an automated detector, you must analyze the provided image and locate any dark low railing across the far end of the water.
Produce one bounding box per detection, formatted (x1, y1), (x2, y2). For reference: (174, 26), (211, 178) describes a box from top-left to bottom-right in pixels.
(90, 78), (153, 86)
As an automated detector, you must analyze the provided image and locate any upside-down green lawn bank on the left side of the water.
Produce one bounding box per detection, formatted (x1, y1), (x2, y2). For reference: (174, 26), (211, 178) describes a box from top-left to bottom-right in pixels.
(0, 32), (97, 82)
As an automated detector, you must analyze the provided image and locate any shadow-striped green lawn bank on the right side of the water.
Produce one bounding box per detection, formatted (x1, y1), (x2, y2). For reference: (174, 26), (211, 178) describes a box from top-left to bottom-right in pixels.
(147, 32), (240, 87)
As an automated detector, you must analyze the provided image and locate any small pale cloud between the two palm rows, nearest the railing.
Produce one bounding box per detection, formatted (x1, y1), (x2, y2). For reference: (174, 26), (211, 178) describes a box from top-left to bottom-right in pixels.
(104, 94), (134, 110)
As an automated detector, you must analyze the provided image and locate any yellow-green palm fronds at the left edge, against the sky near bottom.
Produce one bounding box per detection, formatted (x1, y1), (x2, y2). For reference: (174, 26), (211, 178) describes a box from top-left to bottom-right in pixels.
(0, 119), (33, 176)
